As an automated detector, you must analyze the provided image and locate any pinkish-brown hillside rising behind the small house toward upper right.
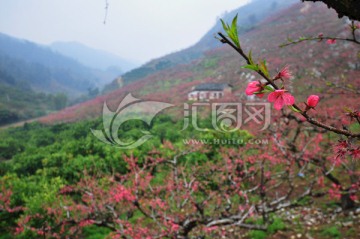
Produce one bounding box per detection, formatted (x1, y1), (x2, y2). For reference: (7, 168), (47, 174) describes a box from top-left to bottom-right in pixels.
(42, 3), (360, 125)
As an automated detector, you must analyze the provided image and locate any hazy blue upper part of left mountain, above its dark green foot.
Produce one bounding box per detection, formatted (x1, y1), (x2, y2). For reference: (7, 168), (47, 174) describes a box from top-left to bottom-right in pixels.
(0, 33), (104, 97)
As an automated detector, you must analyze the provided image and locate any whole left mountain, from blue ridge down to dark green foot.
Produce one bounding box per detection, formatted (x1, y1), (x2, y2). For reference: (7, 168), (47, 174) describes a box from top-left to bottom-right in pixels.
(0, 33), (124, 125)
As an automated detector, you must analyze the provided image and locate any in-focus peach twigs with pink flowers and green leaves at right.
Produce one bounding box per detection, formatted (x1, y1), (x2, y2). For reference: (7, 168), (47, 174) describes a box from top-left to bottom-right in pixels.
(219, 11), (360, 205)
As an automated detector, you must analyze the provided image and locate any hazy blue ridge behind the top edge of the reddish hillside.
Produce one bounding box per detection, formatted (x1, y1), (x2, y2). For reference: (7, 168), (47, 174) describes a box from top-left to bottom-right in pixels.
(105, 0), (297, 92)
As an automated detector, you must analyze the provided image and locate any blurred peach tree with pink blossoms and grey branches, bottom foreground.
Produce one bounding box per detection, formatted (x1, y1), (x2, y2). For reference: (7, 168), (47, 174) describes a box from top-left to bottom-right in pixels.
(17, 139), (326, 239)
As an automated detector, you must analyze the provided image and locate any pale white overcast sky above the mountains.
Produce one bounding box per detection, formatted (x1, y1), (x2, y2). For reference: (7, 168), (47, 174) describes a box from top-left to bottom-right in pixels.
(0, 0), (250, 63)
